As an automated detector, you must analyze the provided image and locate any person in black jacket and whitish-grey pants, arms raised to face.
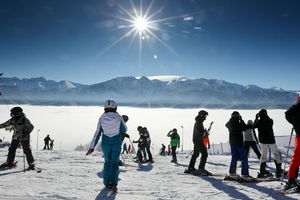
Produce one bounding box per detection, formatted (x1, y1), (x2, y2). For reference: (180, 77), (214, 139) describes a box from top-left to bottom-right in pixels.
(253, 109), (283, 178)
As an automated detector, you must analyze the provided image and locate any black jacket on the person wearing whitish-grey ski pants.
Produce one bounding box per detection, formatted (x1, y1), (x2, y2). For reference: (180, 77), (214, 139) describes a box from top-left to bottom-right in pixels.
(253, 116), (275, 144)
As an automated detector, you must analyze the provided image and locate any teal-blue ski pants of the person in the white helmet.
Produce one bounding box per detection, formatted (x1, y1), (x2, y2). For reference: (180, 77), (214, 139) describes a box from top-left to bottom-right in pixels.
(101, 143), (121, 184)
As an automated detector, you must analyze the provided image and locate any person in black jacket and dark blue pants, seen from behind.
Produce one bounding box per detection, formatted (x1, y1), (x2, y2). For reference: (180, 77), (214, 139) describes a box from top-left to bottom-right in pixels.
(225, 111), (253, 181)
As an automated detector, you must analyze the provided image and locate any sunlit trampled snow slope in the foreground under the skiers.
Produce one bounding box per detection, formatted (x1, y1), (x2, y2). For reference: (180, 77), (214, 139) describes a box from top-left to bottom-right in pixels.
(0, 149), (299, 200)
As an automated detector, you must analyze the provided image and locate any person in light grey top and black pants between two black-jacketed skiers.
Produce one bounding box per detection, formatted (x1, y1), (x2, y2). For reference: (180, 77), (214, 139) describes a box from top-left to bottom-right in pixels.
(243, 120), (261, 159)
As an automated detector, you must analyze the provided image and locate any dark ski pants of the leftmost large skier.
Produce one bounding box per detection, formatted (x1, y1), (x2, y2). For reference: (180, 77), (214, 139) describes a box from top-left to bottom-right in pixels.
(7, 139), (34, 164)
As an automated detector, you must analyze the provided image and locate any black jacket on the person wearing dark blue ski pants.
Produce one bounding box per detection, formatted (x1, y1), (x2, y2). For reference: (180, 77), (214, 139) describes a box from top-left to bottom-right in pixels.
(225, 117), (247, 147)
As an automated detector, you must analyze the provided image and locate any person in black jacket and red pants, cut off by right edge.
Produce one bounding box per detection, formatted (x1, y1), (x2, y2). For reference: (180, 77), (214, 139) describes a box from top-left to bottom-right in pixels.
(284, 96), (300, 190)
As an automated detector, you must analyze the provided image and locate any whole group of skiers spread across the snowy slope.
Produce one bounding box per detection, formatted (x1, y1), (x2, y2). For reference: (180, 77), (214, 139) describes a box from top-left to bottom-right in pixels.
(0, 96), (300, 192)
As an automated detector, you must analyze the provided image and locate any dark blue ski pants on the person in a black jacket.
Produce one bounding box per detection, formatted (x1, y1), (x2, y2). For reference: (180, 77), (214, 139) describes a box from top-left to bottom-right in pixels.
(230, 145), (249, 175)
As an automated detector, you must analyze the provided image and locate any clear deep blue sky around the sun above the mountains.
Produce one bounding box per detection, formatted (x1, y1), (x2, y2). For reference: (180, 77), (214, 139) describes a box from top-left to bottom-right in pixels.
(0, 0), (300, 90)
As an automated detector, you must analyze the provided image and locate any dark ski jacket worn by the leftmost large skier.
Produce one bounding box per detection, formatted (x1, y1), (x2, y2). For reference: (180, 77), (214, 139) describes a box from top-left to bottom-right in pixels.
(0, 115), (34, 140)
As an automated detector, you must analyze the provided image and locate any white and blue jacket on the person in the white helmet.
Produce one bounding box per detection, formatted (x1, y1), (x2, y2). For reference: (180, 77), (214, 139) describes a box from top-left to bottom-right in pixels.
(90, 112), (127, 149)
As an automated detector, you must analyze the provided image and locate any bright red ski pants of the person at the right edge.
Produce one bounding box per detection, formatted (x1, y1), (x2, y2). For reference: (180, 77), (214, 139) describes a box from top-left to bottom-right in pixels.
(288, 136), (300, 179)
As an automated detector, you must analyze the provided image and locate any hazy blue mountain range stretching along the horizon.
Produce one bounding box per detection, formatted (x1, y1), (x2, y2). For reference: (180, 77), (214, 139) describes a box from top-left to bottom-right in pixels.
(0, 76), (297, 109)
